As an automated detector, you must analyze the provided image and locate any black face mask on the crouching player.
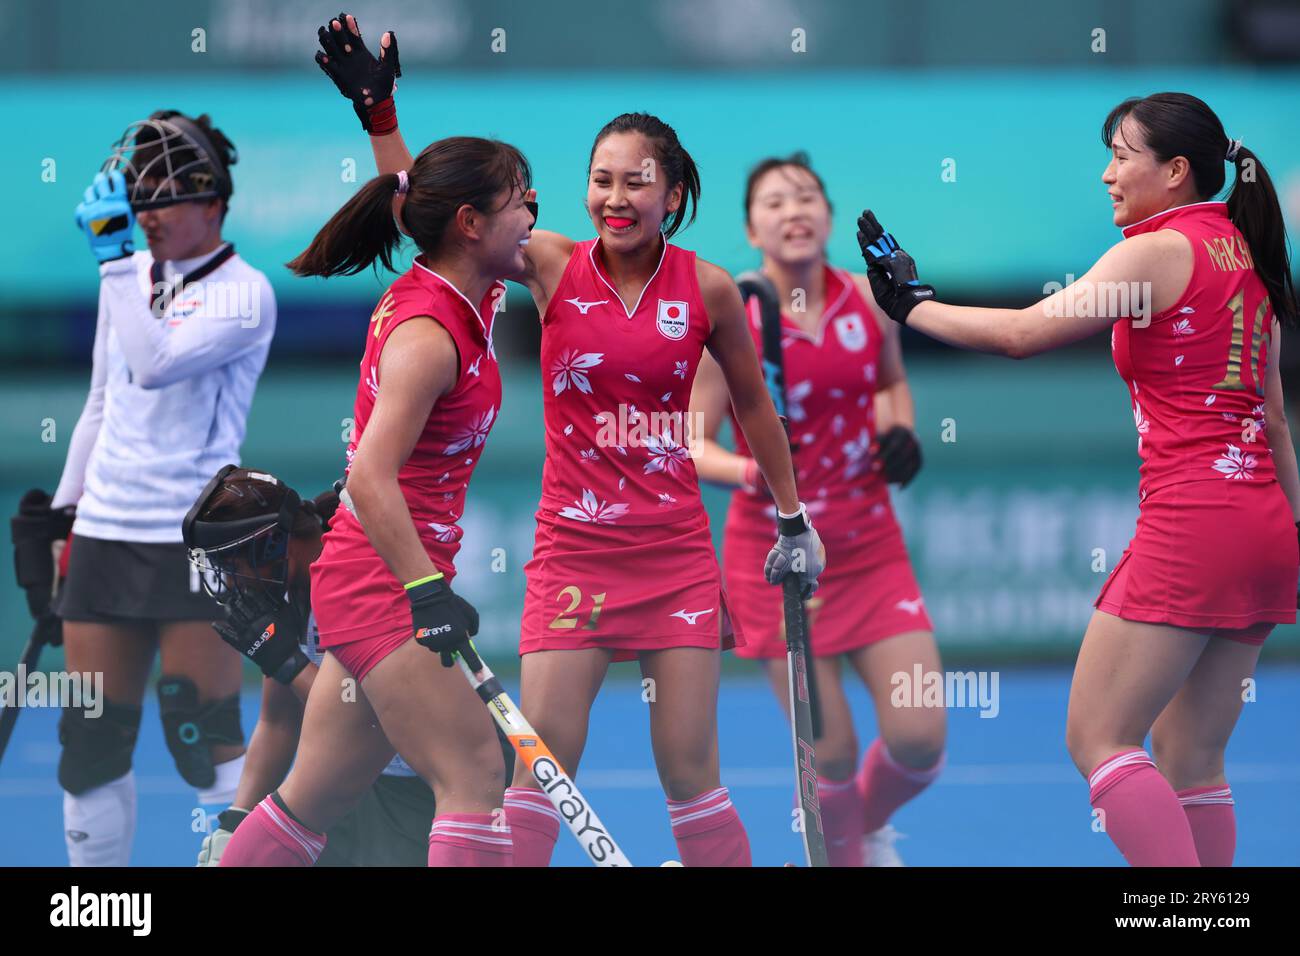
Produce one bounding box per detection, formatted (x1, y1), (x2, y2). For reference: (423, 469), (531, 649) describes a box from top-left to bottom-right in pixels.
(181, 464), (302, 604)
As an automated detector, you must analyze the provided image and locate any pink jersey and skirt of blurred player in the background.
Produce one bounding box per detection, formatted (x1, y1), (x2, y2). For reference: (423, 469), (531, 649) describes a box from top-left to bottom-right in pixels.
(723, 265), (933, 658)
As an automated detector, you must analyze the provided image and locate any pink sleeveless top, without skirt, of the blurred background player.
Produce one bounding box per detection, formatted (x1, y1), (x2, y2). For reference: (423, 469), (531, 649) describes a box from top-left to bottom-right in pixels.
(728, 265), (893, 540)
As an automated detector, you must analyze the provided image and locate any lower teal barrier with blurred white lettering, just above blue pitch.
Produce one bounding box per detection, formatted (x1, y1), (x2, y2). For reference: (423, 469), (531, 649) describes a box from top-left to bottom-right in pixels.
(0, 356), (1300, 670)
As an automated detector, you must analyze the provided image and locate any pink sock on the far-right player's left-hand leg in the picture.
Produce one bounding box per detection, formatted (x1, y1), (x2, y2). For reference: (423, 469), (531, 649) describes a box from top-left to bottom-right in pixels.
(1088, 750), (1200, 866)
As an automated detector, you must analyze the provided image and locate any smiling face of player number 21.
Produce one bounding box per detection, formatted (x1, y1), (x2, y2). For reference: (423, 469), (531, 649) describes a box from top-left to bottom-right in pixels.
(586, 133), (683, 255)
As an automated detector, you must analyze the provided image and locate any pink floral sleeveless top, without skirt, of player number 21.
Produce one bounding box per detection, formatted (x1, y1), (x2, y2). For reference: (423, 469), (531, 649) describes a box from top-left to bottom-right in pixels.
(541, 239), (709, 527)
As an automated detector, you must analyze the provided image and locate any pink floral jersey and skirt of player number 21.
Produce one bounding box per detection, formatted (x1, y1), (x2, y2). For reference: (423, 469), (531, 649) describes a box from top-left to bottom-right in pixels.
(519, 241), (744, 661)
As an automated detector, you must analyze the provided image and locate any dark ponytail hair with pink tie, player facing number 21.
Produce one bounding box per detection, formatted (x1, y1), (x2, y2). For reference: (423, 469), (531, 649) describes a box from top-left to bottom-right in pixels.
(287, 137), (533, 277)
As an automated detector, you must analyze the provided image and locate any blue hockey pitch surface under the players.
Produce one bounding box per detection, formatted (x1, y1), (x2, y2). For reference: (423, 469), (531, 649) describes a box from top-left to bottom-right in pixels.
(0, 665), (1300, 866)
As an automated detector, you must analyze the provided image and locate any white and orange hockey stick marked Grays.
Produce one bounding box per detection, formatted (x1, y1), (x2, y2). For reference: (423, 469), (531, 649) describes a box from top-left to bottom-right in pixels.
(456, 641), (634, 866)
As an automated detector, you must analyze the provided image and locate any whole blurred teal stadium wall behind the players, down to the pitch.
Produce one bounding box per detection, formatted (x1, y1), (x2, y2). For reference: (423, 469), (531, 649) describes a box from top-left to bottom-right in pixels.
(0, 0), (1300, 666)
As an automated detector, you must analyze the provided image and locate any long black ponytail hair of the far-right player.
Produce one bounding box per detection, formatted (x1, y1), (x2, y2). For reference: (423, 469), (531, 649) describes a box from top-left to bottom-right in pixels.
(1101, 92), (1300, 325)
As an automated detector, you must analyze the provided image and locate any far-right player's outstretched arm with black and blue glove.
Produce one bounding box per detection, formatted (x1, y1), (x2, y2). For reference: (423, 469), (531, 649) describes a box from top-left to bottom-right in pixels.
(858, 209), (1192, 359)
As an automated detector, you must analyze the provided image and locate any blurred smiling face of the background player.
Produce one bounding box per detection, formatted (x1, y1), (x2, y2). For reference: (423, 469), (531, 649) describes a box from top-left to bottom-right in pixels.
(745, 165), (831, 268)
